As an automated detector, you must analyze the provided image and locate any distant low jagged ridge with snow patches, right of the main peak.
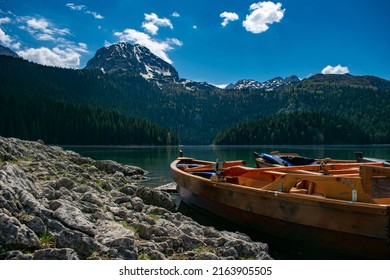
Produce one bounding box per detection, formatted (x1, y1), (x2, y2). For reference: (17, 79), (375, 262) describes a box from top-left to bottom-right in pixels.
(226, 75), (300, 91)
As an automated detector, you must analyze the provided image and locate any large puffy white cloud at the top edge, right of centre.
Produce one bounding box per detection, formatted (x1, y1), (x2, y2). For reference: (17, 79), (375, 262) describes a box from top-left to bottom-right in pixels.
(242, 1), (285, 34)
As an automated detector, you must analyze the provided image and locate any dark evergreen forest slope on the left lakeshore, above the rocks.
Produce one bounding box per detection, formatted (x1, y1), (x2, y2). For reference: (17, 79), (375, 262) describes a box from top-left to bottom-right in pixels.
(0, 92), (178, 145)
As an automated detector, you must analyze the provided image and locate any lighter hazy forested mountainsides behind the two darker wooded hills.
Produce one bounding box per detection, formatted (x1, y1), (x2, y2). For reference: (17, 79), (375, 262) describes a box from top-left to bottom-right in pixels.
(0, 56), (390, 145)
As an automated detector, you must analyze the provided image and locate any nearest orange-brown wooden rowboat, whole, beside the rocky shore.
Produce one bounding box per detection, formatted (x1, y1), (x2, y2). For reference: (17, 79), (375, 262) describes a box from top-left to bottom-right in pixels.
(171, 157), (390, 259)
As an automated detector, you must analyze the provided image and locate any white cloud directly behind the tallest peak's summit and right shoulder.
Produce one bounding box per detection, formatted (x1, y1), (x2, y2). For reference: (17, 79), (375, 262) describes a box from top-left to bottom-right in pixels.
(114, 29), (183, 64)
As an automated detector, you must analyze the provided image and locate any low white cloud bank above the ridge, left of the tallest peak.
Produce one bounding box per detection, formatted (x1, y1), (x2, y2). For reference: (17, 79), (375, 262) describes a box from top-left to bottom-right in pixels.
(17, 47), (81, 68)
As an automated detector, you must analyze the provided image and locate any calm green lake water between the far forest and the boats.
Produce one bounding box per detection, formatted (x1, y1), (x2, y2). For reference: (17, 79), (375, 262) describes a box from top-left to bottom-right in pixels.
(64, 145), (390, 187)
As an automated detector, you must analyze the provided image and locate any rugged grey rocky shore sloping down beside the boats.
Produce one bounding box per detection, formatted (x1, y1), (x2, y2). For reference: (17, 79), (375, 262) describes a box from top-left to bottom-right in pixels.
(0, 137), (271, 260)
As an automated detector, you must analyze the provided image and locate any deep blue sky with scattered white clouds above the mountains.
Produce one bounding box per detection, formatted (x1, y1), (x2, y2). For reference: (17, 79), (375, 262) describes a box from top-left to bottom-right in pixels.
(0, 0), (390, 85)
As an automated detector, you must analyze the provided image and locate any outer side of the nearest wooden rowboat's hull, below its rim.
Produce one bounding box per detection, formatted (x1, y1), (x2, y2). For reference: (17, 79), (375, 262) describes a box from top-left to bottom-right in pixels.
(172, 159), (390, 259)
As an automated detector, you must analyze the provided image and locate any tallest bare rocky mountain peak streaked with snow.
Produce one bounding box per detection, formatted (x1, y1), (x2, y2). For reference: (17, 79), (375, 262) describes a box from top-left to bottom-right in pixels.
(85, 42), (179, 82)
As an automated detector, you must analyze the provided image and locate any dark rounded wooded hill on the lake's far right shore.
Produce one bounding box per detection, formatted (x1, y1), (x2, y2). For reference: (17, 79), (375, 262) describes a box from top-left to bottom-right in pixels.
(214, 111), (371, 145)
